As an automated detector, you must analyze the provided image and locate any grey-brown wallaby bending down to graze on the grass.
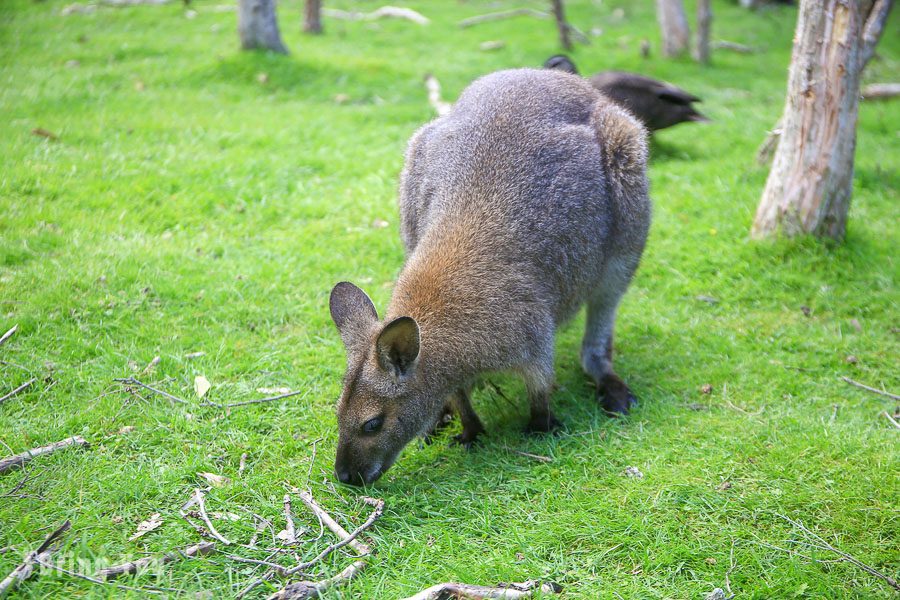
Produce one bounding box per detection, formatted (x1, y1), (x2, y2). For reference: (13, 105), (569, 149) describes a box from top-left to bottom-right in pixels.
(330, 69), (650, 484)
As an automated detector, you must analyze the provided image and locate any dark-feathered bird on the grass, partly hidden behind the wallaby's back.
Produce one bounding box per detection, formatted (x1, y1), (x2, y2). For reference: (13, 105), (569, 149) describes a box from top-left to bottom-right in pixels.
(544, 54), (709, 131)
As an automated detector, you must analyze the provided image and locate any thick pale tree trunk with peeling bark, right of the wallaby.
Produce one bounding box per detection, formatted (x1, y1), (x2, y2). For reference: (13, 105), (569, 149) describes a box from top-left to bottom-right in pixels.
(751, 0), (891, 239)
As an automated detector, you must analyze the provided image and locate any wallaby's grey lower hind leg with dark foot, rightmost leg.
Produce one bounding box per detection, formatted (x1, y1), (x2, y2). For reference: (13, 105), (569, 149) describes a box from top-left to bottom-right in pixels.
(581, 270), (637, 414)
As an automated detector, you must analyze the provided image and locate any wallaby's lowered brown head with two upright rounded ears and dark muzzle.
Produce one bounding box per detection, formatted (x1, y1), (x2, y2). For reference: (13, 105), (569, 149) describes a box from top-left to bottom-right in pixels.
(329, 282), (439, 485)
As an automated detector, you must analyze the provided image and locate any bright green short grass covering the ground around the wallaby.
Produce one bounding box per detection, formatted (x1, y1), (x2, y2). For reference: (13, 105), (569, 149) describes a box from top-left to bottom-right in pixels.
(0, 0), (900, 598)
